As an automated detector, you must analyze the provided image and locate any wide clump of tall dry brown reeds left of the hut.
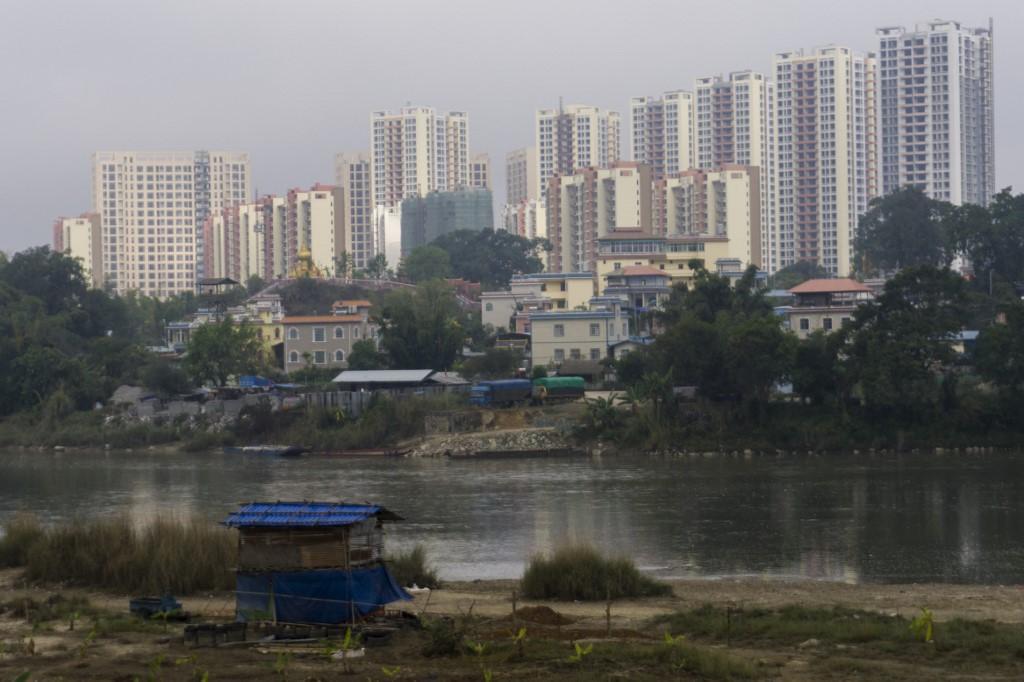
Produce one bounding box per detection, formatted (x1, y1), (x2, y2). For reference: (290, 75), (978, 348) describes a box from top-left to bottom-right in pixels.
(5, 515), (238, 594)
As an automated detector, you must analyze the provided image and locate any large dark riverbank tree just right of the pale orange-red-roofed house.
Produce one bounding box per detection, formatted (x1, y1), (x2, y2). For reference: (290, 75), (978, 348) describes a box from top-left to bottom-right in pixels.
(839, 266), (968, 423)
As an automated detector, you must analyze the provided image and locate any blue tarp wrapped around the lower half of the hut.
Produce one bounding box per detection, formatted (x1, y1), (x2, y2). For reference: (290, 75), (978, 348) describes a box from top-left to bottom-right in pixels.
(236, 565), (413, 625)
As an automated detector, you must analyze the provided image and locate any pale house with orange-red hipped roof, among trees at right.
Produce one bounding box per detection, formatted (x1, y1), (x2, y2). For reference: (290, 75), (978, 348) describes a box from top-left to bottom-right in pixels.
(786, 279), (874, 339)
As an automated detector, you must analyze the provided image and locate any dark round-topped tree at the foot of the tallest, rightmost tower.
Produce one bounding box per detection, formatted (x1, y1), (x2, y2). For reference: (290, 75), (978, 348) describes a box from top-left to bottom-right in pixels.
(854, 186), (952, 273)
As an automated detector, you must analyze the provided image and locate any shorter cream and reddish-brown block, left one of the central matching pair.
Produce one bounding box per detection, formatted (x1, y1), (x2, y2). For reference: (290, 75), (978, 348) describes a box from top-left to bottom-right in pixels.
(547, 162), (652, 272)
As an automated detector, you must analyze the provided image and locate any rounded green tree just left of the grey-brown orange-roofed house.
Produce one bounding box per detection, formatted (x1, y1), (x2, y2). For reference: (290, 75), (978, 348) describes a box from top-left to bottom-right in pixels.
(185, 317), (263, 386)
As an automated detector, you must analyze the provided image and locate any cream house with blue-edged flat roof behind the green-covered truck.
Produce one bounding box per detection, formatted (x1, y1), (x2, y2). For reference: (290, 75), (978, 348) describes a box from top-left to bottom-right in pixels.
(529, 296), (629, 368)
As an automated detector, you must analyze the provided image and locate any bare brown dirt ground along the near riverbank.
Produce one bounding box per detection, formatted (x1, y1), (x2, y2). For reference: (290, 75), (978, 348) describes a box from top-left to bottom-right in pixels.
(0, 570), (1024, 682)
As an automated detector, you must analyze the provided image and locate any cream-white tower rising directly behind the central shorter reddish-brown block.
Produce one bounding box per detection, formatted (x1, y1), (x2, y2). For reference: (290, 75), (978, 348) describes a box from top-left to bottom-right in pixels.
(537, 104), (622, 194)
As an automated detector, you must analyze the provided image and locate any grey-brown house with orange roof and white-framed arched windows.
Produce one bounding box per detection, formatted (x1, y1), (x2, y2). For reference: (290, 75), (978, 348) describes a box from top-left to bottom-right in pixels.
(282, 300), (377, 372)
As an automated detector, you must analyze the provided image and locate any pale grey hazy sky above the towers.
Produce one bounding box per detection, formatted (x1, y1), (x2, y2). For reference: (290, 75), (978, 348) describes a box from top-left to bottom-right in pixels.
(0, 0), (1024, 252)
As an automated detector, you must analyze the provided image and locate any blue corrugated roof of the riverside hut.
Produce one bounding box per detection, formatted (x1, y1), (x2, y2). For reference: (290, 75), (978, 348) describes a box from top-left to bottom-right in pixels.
(224, 502), (401, 528)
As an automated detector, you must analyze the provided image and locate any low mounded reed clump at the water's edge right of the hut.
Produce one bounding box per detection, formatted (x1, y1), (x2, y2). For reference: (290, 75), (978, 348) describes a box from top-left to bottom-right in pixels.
(521, 545), (672, 601)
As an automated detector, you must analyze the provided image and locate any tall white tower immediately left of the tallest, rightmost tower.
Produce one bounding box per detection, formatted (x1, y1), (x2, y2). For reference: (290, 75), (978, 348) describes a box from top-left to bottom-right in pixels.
(771, 46), (878, 276)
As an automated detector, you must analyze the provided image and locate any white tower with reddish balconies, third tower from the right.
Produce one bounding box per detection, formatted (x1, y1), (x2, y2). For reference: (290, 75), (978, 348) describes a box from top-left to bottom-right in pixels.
(693, 71), (777, 272)
